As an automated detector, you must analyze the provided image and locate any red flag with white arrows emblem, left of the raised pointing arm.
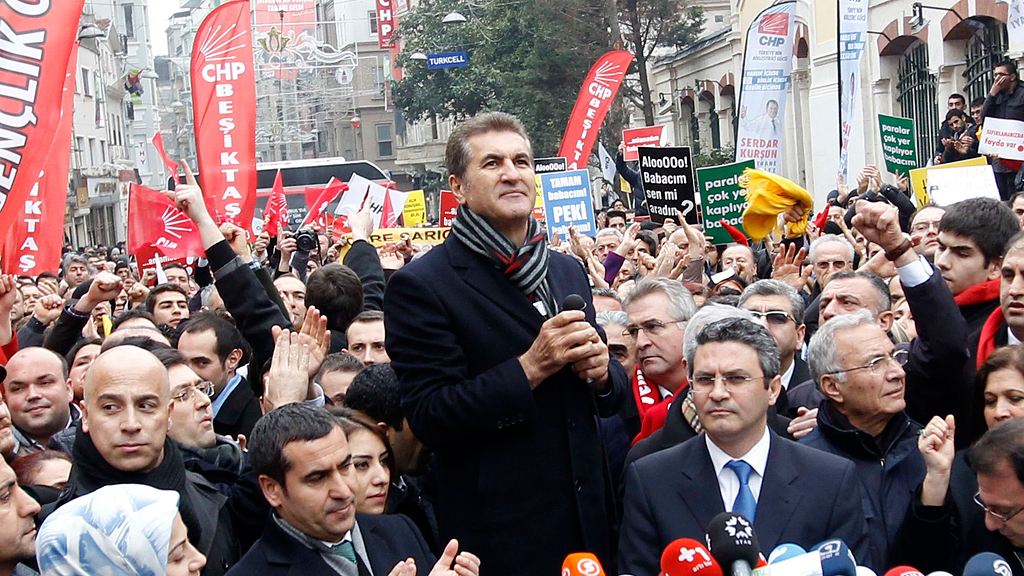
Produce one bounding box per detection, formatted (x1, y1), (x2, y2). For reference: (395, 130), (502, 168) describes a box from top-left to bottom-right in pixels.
(128, 183), (206, 261)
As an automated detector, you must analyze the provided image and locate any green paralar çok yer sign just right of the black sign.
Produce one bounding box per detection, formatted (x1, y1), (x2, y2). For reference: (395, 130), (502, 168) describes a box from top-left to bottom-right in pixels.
(697, 160), (754, 245)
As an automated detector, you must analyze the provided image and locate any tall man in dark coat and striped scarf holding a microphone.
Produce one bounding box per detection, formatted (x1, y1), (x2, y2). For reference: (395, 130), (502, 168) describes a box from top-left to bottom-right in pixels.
(384, 113), (627, 576)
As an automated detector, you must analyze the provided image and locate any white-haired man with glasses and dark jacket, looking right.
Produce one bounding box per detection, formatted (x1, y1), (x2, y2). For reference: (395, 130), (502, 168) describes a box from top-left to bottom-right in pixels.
(800, 310), (925, 571)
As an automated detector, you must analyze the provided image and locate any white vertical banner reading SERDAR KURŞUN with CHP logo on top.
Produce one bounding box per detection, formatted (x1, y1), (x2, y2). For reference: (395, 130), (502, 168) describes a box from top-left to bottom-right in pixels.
(736, 2), (797, 173)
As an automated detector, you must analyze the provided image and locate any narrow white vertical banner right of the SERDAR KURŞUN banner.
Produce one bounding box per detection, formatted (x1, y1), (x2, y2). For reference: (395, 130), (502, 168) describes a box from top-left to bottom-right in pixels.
(838, 0), (868, 178)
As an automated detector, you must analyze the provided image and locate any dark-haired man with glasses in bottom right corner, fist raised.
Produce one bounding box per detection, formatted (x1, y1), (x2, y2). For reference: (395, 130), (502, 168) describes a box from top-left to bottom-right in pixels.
(899, 417), (1024, 576)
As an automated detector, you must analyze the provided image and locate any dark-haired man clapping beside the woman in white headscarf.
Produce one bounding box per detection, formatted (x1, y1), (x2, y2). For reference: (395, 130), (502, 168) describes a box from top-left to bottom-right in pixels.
(229, 404), (480, 576)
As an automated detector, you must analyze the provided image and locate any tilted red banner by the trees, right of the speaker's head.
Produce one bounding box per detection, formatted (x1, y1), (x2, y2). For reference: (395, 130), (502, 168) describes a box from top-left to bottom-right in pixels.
(555, 50), (633, 170)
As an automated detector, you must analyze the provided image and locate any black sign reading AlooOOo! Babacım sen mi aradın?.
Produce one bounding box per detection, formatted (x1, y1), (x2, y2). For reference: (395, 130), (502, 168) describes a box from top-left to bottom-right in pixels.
(639, 147), (700, 224)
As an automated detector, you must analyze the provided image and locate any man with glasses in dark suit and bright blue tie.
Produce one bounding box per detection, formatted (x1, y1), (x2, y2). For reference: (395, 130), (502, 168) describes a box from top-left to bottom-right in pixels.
(618, 318), (867, 576)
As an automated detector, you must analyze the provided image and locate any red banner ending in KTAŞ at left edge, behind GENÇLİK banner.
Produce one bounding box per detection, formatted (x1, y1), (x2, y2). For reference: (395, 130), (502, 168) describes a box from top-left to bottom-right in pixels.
(3, 42), (78, 276)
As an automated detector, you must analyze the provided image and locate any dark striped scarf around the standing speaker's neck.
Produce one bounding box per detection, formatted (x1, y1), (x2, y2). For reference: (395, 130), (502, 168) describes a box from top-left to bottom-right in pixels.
(452, 205), (557, 318)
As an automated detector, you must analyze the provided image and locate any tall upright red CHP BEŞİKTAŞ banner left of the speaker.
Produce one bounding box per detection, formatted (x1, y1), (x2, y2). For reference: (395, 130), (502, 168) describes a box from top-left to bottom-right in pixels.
(191, 0), (256, 234)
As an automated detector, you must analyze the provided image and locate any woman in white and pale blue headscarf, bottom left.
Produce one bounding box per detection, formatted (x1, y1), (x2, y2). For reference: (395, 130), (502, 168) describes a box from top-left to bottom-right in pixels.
(36, 484), (206, 576)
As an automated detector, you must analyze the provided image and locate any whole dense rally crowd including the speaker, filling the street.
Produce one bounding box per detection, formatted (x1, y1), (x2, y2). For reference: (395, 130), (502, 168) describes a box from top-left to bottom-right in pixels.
(0, 65), (1024, 576)
